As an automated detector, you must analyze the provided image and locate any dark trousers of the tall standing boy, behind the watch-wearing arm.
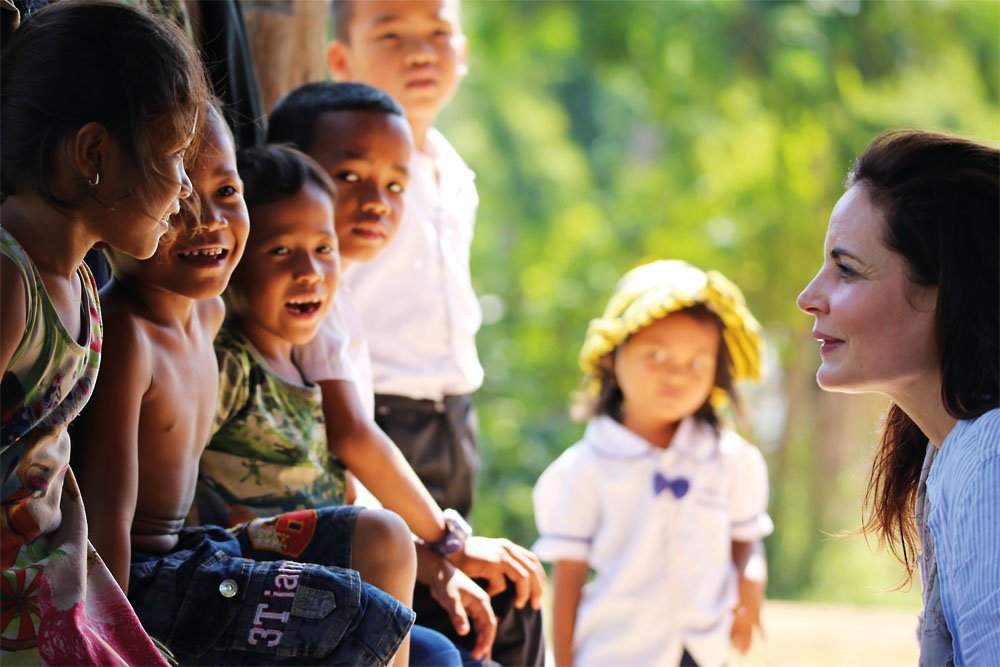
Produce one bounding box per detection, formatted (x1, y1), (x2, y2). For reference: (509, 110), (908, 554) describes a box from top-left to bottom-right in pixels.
(375, 394), (545, 667)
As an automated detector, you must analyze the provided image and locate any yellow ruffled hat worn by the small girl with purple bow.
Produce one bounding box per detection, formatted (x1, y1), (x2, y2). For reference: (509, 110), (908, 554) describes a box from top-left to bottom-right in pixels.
(580, 260), (762, 403)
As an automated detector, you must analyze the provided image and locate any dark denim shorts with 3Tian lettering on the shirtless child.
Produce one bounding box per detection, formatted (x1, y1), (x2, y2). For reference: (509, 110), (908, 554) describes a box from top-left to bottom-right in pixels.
(128, 507), (415, 665)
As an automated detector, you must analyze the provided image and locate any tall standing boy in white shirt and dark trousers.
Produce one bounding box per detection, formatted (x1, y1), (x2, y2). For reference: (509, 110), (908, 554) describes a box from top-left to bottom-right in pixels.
(328, 0), (545, 665)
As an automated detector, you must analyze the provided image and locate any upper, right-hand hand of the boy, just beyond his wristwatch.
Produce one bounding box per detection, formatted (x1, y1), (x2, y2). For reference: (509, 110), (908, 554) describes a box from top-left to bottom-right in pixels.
(448, 536), (545, 609)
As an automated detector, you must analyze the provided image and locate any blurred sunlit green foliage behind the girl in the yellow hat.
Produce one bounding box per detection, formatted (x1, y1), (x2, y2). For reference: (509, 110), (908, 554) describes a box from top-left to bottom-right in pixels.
(439, 0), (1000, 604)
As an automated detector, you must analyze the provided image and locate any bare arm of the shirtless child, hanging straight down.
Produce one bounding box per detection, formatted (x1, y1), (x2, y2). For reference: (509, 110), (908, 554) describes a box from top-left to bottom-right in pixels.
(79, 317), (151, 591)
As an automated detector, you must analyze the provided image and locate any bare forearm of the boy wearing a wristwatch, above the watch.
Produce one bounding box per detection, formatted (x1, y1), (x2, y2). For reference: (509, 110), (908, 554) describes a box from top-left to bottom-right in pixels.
(319, 380), (445, 542)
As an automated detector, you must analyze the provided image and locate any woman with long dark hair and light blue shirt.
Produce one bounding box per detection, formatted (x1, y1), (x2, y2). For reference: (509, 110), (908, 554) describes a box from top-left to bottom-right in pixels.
(798, 131), (1000, 665)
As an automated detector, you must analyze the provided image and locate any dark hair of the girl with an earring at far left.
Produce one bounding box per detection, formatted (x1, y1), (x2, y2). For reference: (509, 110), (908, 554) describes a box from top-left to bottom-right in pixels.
(0, 0), (209, 213)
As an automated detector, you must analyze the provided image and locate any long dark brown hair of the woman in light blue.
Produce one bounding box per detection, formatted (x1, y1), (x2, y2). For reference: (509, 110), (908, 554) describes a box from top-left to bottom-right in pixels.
(847, 130), (1000, 581)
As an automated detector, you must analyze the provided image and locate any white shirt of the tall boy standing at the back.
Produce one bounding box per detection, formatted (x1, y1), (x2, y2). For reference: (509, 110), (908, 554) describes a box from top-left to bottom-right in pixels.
(344, 129), (483, 400)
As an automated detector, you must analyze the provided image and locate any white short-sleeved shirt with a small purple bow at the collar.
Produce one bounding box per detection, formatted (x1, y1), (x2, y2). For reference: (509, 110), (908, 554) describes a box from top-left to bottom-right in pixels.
(533, 416), (773, 667)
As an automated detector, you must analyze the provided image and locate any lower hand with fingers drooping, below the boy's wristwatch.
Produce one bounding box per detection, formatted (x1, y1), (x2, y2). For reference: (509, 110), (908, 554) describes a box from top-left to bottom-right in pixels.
(430, 557), (497, 660)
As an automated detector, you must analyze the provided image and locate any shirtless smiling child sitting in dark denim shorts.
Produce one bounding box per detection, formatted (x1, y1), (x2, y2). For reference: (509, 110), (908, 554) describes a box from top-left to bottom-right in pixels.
(80, 104), (415, 664)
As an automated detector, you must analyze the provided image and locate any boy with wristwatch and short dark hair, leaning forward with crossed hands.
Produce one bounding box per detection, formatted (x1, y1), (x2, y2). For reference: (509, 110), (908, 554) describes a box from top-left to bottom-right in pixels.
(268, 77), (544, 664)
